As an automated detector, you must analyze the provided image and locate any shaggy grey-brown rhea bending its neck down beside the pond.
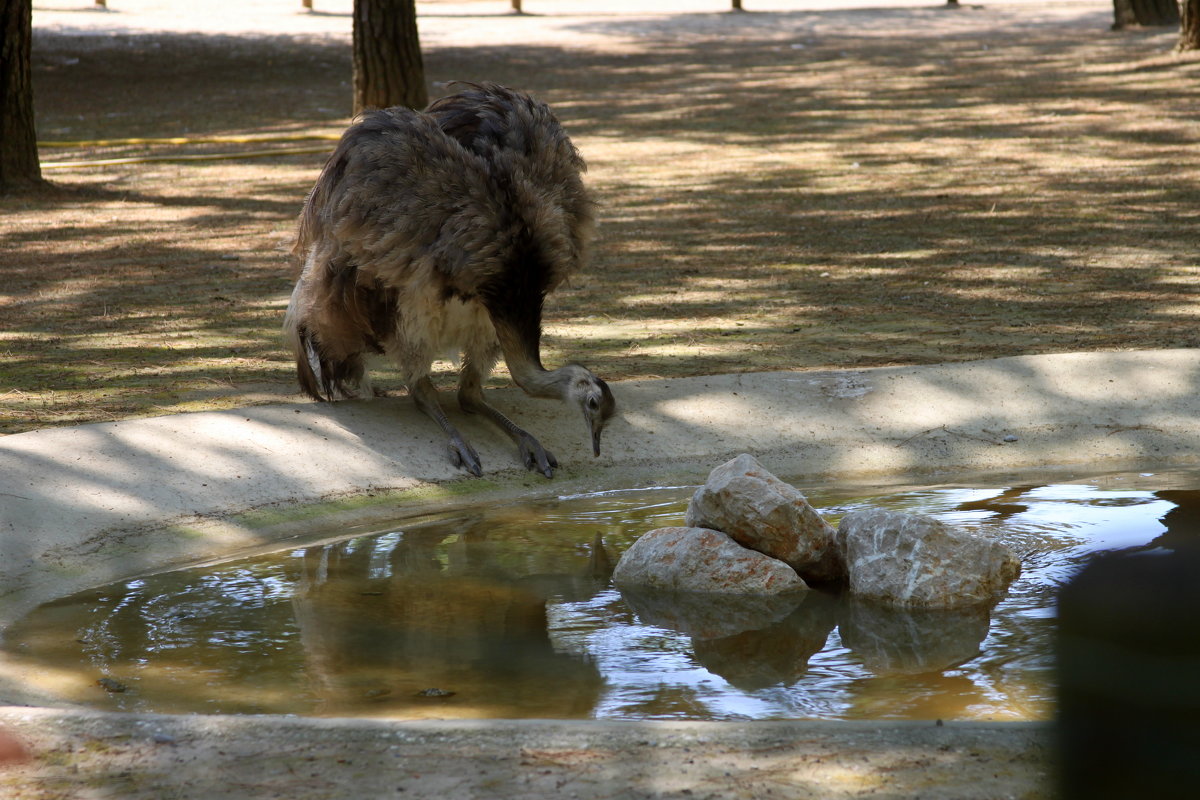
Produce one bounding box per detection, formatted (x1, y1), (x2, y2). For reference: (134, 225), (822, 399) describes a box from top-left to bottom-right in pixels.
(284, 84), (616, 477)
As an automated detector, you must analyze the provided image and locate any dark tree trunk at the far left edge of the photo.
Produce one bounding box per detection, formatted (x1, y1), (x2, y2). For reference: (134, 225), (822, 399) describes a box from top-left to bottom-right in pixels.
(0, 0), (42, 192)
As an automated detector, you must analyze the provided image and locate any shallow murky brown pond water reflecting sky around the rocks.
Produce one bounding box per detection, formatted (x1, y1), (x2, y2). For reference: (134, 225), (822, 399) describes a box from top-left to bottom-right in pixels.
(2, 473), (1200, 720)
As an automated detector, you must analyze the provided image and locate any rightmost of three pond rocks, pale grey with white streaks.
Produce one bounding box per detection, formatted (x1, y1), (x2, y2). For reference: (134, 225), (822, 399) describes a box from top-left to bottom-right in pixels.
(838, 509), (1021, 608)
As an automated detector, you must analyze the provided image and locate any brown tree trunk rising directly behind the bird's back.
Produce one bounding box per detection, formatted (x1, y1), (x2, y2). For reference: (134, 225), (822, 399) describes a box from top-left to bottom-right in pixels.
(354, 0), (430, 114)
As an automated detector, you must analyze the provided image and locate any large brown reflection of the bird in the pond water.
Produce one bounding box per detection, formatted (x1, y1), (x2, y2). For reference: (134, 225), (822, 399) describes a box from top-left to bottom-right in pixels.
(293, 527), (604, 717)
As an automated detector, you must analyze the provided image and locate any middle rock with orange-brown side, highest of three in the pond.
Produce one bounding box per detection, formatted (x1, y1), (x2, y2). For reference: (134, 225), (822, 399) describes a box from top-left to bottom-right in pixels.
(686, 453), (845, 581)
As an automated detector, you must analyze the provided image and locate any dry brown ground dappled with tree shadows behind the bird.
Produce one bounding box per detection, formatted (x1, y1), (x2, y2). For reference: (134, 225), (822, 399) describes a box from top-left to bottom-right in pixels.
(0, 2), (1200, 433)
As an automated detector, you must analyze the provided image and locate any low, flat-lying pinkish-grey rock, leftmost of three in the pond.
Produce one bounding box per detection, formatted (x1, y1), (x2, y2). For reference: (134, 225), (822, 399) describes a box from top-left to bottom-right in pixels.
(612, 528), (808, 595)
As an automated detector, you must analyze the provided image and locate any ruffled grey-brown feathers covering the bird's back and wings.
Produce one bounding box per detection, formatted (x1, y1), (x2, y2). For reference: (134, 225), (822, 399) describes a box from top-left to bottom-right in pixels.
(295, 85), (592, 302)
